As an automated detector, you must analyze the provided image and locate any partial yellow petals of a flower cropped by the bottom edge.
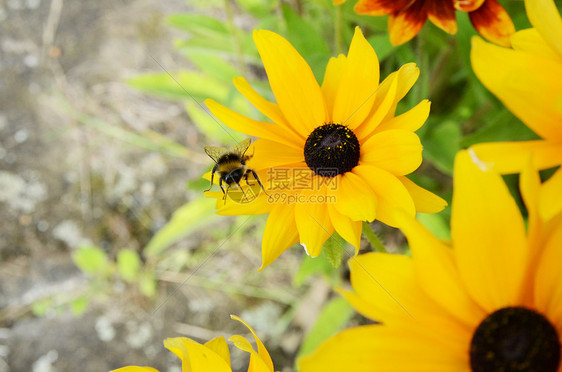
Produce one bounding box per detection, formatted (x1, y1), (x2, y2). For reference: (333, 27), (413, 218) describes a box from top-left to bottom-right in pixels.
(113, 315), (274, 372)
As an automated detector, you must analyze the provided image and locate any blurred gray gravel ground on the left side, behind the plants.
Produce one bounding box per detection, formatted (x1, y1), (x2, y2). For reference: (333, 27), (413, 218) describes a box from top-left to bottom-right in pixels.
(0, 0), (298, 372)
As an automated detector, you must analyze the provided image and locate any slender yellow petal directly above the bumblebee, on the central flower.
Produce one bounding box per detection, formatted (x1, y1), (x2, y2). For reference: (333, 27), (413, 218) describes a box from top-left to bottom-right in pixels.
(205, 99), (300, 148)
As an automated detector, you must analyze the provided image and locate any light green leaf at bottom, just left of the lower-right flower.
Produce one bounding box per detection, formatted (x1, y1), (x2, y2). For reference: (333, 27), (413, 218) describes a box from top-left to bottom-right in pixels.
(298, 297), (354, 357)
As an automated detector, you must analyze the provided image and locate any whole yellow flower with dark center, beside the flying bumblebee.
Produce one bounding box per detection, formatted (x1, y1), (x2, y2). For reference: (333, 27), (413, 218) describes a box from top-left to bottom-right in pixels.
(206, 28), (446, 268)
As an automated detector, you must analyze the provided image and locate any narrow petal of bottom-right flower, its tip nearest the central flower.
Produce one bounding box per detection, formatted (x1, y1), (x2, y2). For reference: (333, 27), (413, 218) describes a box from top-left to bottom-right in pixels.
(396, 213), (485, 326)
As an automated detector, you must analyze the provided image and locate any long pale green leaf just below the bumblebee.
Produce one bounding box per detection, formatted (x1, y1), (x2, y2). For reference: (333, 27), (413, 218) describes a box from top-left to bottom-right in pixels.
(144, 197), (218, 257)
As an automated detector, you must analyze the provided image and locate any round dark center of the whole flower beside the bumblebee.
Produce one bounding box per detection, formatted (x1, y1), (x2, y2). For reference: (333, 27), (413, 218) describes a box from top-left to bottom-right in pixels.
(304, 123), (360, 177)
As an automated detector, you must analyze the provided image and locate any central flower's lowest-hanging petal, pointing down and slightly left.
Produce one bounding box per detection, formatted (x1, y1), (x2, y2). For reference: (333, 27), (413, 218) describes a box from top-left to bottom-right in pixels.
(259, 204), (299, 270)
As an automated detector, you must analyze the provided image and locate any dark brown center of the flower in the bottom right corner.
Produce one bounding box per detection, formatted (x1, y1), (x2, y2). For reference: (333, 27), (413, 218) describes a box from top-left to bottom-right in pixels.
(470, 307), (560, 372)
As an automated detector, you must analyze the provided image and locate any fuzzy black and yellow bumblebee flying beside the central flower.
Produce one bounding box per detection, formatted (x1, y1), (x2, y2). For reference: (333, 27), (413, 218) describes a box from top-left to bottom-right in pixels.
(205, 138), (267, 203)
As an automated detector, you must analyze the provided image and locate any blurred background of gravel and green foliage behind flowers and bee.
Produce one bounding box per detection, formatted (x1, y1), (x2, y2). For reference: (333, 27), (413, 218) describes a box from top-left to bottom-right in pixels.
(0, 0), (533, 372)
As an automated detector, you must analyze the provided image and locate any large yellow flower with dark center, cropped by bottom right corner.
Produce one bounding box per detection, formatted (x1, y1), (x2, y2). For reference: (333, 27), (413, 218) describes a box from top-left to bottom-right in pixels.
(300, 151), (562, 372)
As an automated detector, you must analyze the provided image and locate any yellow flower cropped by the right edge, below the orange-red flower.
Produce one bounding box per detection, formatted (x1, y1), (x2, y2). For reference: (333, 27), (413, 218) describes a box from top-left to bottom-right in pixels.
(471, 0), (562, 173)
